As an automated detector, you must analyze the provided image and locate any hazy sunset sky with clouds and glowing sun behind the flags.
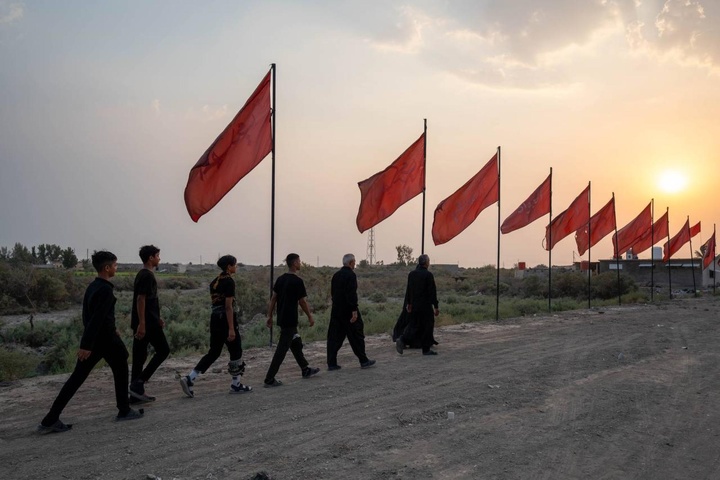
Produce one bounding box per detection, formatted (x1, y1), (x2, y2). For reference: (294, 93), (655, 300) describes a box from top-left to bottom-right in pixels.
(0, 0), (720, 268)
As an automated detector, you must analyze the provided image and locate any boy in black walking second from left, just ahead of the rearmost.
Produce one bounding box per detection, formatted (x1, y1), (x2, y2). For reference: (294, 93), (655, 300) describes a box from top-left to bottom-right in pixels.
(130, 245), (170, 403)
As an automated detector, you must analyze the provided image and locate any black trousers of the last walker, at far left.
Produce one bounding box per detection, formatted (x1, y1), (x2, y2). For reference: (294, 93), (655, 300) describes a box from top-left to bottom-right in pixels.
(42, 336), (130, 426)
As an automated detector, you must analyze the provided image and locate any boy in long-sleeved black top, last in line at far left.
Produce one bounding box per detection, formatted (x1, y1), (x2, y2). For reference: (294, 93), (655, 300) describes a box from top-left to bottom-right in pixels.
(37, 252), (143, 433)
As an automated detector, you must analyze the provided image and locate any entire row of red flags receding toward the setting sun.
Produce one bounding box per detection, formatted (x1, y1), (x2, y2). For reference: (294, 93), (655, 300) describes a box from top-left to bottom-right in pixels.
(185, 72), (715, 268)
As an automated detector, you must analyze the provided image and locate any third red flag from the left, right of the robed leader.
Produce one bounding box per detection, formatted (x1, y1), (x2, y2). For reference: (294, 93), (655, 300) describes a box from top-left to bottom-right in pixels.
(432, 154), (499, 245)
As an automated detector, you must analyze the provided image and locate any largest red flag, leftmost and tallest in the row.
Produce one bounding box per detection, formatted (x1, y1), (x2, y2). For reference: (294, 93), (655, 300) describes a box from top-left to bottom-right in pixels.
(185, 72), (272, 222)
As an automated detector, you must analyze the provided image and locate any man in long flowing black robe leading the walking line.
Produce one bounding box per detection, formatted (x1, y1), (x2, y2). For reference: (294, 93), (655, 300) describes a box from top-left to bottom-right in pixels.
(395, 254), (440, 355)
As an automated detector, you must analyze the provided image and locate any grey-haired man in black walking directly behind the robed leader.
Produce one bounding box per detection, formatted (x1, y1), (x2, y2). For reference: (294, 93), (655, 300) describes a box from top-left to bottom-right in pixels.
(327, 253), (375, 370)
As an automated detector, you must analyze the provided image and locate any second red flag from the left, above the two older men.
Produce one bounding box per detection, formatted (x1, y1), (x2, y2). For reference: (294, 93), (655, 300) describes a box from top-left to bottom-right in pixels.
(356, 133), (425, 233)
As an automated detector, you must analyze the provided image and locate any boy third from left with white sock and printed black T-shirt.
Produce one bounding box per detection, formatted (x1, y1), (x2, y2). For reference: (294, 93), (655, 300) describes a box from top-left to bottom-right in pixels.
(179, 255), (252, 398)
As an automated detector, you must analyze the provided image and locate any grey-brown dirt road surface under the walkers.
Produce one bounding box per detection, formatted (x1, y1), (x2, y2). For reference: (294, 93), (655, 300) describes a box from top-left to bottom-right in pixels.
(0, 298), (720, 480)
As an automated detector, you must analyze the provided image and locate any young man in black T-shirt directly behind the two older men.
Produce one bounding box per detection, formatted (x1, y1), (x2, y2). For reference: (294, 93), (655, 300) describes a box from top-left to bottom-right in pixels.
(265, 253), (320, 387)
